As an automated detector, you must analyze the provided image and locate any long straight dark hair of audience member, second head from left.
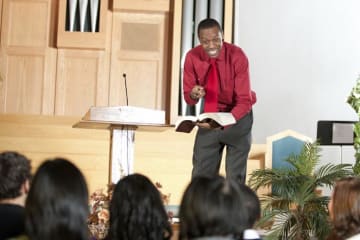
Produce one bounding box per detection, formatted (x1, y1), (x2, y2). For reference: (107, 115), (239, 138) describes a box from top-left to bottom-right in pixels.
(25, 158), (89, 240)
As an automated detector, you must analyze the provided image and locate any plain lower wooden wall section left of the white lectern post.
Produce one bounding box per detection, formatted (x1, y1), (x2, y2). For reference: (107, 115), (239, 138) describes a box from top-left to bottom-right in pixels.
(0, 114), (110, 195)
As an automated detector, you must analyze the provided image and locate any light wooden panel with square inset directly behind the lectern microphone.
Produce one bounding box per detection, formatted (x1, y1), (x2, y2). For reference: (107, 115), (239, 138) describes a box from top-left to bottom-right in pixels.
(109, 12), (170, 110)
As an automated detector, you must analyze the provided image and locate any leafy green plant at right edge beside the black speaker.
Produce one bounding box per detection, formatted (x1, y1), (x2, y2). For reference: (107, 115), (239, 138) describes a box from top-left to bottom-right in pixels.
(347, 76), (360, 175)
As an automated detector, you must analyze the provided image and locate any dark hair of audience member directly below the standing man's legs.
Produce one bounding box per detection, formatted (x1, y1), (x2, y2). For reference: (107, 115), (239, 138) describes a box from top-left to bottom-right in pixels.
(179, 176), (248, 239)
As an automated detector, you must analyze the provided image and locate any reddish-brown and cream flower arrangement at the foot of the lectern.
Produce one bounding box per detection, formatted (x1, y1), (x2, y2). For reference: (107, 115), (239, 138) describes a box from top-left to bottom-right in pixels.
(88, 182), (172, 240)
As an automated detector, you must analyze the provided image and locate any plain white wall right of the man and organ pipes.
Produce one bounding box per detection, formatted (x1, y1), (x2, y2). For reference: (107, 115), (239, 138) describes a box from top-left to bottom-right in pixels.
(237, 0), (360, 143)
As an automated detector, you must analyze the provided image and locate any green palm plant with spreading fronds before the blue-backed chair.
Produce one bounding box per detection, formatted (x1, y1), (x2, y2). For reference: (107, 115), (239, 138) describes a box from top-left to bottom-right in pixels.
(249, 142), (353, 240)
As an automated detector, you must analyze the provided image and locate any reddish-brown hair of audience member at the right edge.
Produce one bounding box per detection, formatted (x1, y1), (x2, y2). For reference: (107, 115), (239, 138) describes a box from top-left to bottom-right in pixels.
(329, 177), (360, 239)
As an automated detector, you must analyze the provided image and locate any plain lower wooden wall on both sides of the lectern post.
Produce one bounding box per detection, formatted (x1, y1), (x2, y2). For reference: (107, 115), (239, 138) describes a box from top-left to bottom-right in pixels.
(0, 114), (266, 205)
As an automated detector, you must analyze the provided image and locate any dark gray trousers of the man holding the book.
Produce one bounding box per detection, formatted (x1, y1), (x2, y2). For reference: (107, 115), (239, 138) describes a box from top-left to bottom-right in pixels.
(192, 111), (253, 183)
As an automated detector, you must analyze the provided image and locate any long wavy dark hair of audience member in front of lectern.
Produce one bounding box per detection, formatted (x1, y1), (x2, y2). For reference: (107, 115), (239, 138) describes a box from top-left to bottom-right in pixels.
(107, 174), (172, 240)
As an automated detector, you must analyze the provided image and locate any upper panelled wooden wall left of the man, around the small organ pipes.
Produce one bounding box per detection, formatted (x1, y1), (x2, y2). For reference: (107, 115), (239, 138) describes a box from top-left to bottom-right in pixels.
(0, 0), (173, 116)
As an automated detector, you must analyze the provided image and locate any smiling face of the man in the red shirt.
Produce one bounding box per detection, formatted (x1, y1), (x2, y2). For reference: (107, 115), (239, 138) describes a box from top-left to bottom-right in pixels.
(199, 27), (223, 58)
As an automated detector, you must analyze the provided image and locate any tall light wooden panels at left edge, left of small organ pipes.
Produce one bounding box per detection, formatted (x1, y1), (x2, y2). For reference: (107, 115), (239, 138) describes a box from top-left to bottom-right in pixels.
(0, 0), (56, 114)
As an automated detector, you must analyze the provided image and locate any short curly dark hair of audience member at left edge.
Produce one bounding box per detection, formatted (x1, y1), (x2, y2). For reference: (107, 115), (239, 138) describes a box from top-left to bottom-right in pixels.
(0, 151), (31, 199)
